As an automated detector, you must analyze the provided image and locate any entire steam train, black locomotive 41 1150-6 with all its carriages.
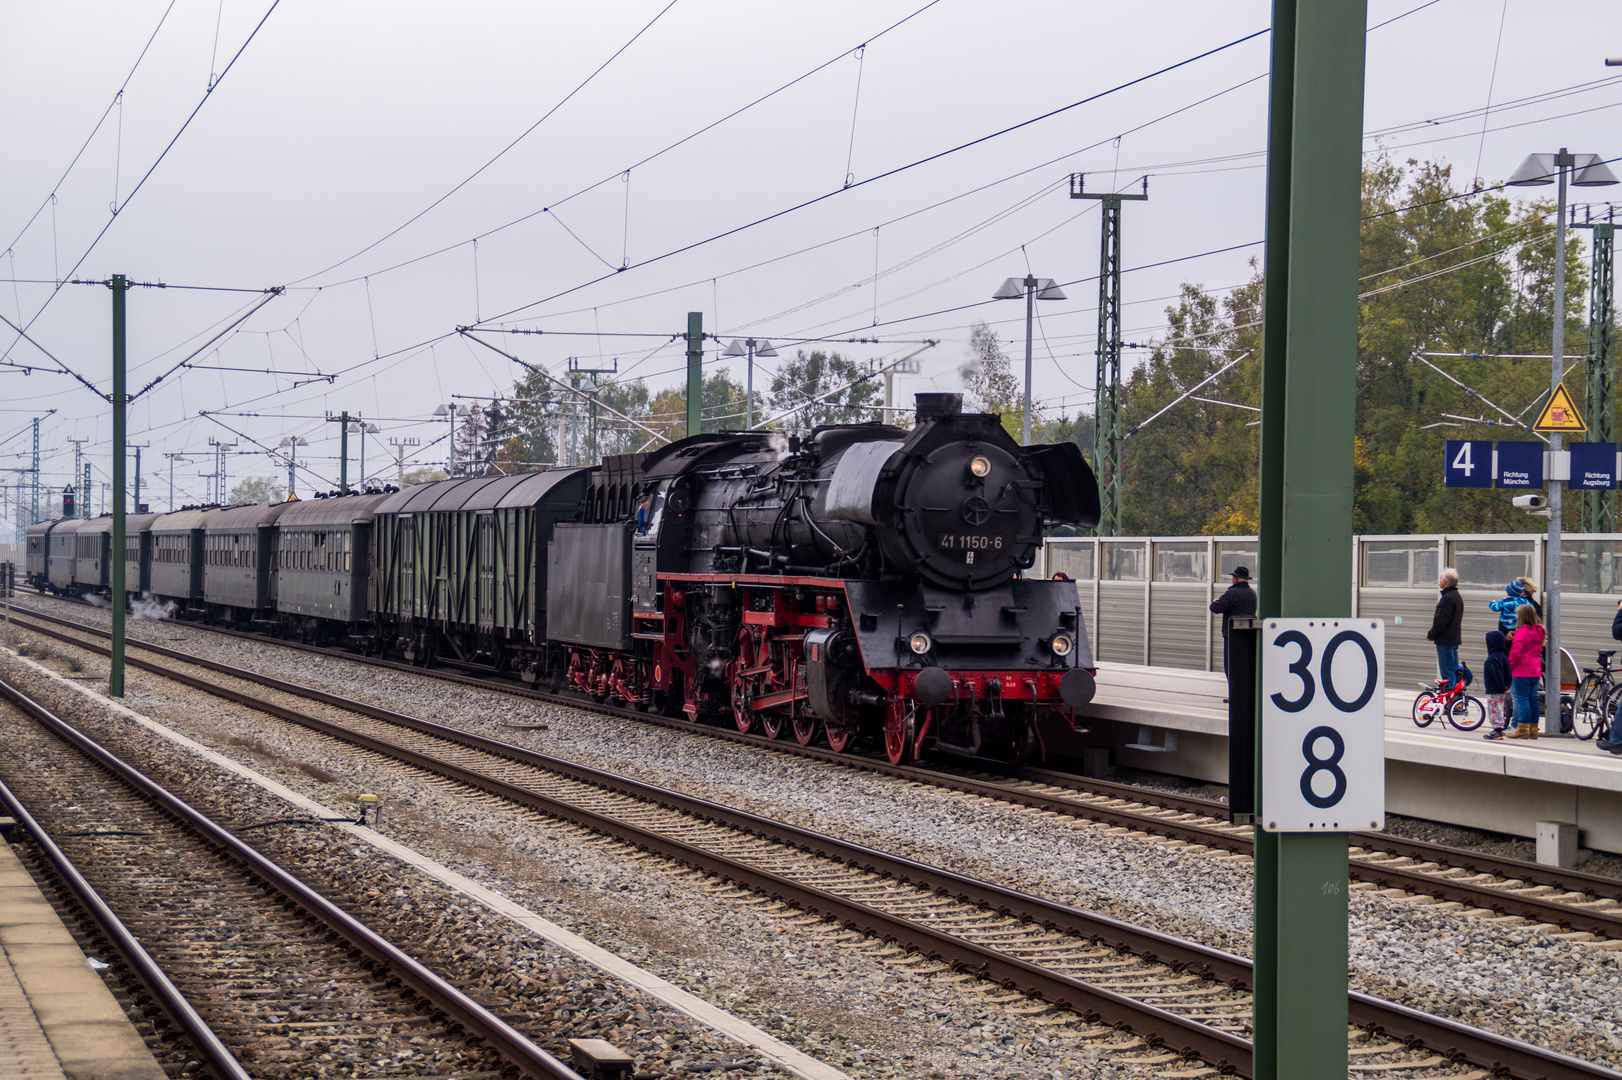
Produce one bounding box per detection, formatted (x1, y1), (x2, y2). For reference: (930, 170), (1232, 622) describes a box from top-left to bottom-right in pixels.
(29, 394), (1098, 762)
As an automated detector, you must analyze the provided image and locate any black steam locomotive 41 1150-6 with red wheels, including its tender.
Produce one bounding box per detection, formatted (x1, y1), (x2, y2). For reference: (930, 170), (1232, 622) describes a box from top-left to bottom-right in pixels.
(547, 394), (1098, 762)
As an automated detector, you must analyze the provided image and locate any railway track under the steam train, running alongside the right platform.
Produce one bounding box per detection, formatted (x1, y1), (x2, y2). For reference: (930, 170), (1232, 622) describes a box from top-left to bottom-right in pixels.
(19, 600), (1622, 941)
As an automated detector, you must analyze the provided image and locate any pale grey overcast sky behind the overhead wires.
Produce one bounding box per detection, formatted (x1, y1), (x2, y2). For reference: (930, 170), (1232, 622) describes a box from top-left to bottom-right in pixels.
(0, 0), (1622, 518)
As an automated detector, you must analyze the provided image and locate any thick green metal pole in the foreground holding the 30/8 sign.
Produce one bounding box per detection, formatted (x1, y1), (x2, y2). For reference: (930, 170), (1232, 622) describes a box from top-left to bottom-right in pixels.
(1254, 0), (1366, 1080)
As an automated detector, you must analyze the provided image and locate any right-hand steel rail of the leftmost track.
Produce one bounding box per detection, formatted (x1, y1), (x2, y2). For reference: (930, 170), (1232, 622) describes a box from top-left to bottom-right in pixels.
(0, 679), (582, 1080)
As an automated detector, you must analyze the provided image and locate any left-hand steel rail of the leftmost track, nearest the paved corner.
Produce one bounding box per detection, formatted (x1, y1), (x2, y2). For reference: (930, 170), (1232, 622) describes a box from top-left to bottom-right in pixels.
(0, 755), (253, 1080)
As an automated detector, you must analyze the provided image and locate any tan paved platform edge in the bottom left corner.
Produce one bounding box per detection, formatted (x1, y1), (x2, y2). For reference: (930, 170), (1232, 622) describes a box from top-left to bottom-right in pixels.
(0, 817), (164, 1080)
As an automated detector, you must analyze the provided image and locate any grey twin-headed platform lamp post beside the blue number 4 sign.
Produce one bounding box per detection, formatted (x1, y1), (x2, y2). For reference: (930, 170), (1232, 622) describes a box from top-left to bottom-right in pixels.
(1507, 146), (1617, 731)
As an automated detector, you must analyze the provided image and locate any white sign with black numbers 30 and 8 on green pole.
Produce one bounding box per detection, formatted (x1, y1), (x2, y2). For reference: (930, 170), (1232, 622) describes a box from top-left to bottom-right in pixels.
(1259, 616), (1385, 832)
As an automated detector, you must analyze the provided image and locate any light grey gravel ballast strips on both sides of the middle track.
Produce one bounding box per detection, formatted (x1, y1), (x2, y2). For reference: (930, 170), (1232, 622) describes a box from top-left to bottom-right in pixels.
(3, 605), (1622, 1078)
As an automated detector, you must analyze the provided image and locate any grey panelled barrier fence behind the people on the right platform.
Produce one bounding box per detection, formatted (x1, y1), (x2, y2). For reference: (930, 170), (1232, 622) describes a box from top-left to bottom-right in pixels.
(1032, 534), (1622, 688)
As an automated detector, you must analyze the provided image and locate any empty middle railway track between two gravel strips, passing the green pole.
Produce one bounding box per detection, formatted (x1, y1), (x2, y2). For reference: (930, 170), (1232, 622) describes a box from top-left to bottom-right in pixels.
(6, 606), (1617, 1077)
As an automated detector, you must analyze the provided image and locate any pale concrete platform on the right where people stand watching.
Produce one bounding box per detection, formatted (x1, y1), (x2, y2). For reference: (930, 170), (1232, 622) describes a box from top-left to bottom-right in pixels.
(1077, 663), (1622, 853)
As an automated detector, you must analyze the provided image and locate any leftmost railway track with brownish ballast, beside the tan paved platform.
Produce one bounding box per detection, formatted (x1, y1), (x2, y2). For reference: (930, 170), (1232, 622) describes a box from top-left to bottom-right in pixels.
(0, 683), (579, 1080)
